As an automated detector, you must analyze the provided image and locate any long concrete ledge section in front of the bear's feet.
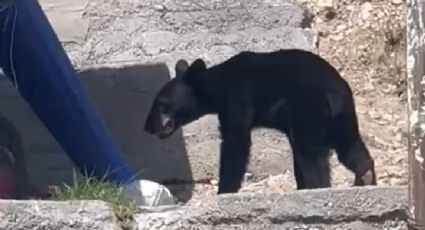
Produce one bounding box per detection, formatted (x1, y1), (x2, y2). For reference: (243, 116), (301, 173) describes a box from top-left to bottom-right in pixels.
(136, 187), (408, 230)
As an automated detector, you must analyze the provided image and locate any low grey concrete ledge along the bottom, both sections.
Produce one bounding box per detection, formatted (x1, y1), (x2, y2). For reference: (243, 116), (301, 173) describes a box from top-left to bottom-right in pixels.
(0, 187), (408, 230)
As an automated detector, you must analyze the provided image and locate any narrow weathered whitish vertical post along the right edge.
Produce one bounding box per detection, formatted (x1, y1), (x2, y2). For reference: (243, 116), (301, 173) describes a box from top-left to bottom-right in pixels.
(406, 0), (425, 226)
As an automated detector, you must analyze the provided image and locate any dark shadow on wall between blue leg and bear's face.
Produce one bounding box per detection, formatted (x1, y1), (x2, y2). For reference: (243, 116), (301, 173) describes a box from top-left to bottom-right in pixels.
(80, 64), (193, 200)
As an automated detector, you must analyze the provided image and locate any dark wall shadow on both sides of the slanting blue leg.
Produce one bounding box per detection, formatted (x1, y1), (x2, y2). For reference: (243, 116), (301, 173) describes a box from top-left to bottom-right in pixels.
(0, 64), (193, 201)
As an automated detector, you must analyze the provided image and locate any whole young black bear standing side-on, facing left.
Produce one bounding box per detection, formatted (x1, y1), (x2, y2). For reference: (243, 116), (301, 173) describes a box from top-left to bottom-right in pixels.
(144, 49), (376, 194)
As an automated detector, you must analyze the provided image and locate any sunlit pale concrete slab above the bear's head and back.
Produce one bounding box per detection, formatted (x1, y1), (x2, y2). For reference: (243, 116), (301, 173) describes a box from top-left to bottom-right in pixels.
(68, 0), (314, 71)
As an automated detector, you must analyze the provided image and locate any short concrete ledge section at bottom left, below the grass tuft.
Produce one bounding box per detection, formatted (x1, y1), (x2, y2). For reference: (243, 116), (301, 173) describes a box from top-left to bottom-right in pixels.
(0, 200), (119, 230)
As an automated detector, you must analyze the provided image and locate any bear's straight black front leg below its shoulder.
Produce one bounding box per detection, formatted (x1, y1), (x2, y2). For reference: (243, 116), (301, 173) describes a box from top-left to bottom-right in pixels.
(218, 100), (251, 194)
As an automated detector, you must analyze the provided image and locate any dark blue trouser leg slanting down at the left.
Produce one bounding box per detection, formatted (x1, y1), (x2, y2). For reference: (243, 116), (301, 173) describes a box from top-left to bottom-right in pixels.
(0, 0), (133, 183)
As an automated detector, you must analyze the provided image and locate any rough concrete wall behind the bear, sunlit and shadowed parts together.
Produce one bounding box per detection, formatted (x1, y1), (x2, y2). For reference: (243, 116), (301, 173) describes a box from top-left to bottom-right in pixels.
(0, 0), (314, 185)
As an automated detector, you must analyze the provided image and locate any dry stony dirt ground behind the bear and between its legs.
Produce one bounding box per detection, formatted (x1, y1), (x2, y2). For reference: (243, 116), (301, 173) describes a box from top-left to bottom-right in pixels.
(171, 0), (408, 201)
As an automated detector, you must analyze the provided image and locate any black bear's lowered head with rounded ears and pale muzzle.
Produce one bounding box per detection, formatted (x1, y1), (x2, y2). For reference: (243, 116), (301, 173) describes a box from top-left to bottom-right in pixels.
(144, 59), (207, 139)
